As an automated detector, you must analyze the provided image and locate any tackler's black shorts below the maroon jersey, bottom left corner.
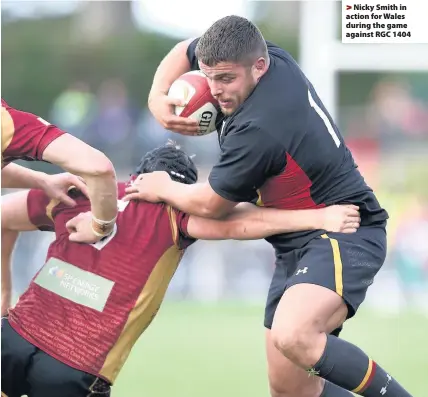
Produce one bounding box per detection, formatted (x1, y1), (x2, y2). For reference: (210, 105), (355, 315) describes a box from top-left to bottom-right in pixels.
(1, 318), (110, 397)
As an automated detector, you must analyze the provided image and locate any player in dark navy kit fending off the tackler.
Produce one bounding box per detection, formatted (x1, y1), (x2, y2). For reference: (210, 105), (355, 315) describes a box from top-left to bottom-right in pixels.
(127, 16), (410, 397)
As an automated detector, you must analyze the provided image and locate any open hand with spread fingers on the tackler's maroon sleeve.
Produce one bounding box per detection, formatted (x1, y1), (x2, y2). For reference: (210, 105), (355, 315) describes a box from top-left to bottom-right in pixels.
(40, 172), (88, 207)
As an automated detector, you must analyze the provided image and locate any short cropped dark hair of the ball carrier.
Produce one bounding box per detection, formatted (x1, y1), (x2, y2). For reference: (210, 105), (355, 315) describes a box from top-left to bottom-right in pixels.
(195, 15), (268, 67)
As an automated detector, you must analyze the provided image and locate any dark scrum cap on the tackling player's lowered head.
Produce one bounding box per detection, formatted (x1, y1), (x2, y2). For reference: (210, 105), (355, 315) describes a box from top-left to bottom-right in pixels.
(133, 141), (198, 185)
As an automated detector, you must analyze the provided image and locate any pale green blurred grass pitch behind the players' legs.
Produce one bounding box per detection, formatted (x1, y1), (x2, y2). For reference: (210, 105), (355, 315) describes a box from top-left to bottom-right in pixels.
(113, 303), (428, 397)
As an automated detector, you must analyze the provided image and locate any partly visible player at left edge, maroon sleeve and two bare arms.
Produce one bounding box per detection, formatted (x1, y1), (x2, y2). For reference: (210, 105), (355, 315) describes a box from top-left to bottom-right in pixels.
(1, 99), (117, 242)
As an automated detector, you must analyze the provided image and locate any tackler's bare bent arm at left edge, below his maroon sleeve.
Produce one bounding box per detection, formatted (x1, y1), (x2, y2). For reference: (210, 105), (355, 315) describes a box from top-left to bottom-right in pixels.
(1, 191), (37, 316)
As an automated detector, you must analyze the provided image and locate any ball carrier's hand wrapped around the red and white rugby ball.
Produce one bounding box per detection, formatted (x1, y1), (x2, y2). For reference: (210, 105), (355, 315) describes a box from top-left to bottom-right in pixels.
(149, 93), (199, 135)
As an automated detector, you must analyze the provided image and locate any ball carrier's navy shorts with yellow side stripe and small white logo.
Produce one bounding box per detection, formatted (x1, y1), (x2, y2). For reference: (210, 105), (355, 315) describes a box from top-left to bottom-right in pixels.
(264, 225), (386, 335)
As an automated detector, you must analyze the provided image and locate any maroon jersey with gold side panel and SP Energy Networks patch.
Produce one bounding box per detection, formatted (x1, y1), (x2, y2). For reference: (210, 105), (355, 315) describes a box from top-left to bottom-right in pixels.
(9, 184), (195, 383)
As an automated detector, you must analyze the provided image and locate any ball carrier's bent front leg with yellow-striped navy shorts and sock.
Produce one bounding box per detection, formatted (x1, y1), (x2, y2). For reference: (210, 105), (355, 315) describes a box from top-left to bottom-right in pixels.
(272, 227), (410, 397)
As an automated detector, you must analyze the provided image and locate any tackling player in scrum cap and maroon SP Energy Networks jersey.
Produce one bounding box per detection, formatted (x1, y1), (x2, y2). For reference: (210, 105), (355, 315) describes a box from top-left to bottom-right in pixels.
(1, 145), (359, 397)
